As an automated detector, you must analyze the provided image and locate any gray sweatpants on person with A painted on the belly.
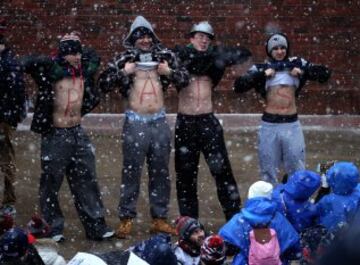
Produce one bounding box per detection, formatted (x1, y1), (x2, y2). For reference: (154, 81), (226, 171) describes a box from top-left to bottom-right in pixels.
(119, 113), (171, 219)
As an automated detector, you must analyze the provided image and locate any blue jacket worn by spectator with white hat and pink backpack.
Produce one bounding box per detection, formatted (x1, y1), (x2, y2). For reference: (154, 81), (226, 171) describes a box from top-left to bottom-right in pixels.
(219, 197), (300, 265)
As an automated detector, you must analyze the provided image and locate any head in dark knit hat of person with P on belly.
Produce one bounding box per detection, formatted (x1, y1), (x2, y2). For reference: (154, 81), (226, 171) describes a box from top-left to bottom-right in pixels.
(59, 31), (82, 63)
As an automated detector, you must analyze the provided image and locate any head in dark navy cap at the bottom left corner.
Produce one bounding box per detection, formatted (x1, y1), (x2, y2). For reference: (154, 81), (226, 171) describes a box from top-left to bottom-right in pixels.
(0, 227), (30, 261)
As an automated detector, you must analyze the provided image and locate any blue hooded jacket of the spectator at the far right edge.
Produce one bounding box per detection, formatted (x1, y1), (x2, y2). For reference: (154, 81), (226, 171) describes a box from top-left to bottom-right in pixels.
(317, 162), (360, 232)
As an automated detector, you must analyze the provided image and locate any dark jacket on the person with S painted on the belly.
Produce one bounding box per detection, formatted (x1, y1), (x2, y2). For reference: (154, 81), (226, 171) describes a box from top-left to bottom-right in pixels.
(234, 57), (331, 98)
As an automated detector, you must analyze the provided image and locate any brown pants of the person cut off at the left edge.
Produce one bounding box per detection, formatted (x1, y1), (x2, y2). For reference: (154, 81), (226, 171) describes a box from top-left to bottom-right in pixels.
(0, 123), (16, 205)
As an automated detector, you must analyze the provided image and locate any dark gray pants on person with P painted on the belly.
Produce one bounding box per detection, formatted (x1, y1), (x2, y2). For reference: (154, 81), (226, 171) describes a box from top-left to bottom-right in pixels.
(40, 126), (107, 238)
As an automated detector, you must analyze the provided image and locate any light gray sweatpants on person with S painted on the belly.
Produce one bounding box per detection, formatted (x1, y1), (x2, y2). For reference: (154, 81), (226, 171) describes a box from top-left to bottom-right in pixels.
(258, 121), (305, 183)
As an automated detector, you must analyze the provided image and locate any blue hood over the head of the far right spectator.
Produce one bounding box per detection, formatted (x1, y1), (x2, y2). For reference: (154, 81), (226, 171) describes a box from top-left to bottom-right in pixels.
(326, 162), (359, 195)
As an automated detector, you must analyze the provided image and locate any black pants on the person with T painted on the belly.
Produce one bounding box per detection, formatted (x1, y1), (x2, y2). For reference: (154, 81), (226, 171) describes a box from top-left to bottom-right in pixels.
(175, 113), (241, 220)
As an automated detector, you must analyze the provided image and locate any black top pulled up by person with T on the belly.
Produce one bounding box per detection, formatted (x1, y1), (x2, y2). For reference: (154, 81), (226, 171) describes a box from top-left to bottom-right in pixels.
(174, 44), (251, 87)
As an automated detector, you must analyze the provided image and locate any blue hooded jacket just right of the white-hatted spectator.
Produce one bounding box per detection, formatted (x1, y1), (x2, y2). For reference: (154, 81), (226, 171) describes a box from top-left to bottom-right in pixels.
(272, 170), (320, 233)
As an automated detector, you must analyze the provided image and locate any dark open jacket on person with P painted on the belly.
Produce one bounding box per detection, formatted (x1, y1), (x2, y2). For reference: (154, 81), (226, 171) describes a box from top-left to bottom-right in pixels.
(22, 48), (100, 134)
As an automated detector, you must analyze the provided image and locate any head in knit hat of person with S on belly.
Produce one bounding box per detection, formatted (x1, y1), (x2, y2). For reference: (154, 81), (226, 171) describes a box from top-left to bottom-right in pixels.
(266, 33), (289, 61)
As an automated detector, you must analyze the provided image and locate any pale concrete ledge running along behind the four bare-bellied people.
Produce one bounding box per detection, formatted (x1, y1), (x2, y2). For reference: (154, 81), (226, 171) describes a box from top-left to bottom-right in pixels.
(18, 113), (360, 134)
